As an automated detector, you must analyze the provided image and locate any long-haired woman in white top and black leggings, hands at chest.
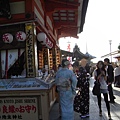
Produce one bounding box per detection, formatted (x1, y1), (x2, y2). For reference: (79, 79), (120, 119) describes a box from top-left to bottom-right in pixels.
(94, 61), (111, 120)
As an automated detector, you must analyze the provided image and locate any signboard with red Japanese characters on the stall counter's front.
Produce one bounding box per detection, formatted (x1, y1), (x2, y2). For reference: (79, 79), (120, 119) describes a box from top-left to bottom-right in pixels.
(0, 97), (38, 120)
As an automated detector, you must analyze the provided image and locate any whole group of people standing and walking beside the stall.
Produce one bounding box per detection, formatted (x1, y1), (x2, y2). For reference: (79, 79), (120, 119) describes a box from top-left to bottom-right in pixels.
(55, 58), (120, 120)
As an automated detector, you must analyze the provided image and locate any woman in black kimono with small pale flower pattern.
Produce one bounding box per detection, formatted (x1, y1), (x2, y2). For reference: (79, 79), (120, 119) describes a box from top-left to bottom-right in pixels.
(74, 59), (89, 118)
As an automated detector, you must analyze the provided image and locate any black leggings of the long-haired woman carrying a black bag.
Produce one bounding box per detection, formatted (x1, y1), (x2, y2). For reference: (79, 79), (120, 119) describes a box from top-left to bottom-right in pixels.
(97, 93), (110, 115)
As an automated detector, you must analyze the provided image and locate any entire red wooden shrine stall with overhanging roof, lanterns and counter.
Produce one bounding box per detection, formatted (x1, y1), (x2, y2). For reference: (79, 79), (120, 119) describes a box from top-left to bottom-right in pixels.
(0, 0), (88, 120)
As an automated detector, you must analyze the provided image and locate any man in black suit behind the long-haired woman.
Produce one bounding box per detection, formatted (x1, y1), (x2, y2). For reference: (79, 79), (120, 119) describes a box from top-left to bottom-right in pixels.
(104, 58), (115, 103)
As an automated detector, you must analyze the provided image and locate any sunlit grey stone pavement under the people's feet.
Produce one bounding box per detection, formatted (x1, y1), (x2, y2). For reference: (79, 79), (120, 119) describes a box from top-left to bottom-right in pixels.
(50, 78), (120, 120)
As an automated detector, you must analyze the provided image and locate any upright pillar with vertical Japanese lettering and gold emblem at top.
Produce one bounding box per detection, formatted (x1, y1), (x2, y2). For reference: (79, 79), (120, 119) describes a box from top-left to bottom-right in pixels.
(25, 23), (38, 77)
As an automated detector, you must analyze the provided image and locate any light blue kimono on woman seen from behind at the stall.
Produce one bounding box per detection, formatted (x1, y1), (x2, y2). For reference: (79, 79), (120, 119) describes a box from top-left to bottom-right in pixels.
(55, 68), (77, 120)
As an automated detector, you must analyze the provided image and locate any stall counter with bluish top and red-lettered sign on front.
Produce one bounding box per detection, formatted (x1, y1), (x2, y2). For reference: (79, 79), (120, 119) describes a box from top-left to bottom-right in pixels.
(0, 78), (56, 120)
